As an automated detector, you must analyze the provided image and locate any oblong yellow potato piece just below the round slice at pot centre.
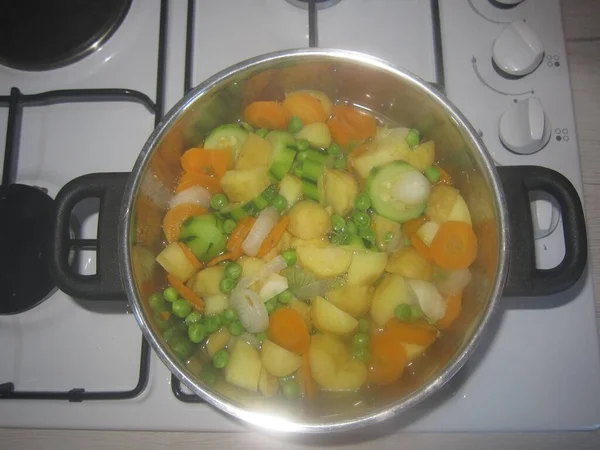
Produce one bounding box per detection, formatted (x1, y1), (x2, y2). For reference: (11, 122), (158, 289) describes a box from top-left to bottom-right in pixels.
(296, 245), (352, 278)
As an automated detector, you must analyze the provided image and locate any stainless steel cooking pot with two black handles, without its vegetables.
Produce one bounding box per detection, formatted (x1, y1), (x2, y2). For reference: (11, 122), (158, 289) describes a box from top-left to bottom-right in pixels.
(51, 49), (587, 432)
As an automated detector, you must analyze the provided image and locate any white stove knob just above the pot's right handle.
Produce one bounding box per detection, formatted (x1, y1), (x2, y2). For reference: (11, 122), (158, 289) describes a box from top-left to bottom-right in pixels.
(498, 97), (551, 155)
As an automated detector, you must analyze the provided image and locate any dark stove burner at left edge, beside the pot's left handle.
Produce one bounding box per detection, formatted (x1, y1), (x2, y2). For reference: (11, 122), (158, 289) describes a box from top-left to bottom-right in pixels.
(0, 184), (54, 315)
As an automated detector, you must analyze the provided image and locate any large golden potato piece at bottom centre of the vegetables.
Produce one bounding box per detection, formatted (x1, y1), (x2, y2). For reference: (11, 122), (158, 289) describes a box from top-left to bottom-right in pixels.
(309, 334), (367, 391)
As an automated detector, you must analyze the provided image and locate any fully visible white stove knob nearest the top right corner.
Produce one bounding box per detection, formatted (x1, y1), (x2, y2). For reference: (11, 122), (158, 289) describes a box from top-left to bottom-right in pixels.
(492, 20), (544, 78)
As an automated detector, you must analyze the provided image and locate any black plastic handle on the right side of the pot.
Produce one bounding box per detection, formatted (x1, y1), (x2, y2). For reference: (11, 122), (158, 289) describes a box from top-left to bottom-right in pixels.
(497, 166), (587, 297)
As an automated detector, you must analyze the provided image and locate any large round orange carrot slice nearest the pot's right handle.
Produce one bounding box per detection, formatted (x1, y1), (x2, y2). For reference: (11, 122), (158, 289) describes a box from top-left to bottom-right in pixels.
(430, 221), (477, 269)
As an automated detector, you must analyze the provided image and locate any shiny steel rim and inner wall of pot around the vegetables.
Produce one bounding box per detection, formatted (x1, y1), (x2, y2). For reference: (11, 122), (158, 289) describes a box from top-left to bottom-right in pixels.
(126, 50), (506, 431)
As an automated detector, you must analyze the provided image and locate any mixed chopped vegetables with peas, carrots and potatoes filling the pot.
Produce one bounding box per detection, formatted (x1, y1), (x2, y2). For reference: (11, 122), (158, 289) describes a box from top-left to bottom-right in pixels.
(149, 91), (477, 399)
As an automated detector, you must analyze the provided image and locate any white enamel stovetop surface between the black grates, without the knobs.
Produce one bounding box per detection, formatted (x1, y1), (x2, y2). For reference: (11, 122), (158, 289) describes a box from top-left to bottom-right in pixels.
(0, 0), (600, 433)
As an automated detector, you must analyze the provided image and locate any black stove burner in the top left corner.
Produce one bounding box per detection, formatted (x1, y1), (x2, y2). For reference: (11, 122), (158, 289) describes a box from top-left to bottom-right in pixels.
(0, 0), (132, 71)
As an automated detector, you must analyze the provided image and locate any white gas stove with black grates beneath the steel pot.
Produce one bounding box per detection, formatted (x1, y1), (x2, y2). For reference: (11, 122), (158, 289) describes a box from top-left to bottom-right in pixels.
(0, 0), (600, 432)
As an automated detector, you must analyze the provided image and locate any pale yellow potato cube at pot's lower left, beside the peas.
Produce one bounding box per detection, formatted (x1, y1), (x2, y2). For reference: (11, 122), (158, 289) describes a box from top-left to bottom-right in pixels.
(225, 339), (262, 392)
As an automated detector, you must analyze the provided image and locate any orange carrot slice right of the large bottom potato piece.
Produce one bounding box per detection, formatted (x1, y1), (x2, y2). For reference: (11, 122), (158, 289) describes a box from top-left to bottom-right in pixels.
(368, 330), (407, 386)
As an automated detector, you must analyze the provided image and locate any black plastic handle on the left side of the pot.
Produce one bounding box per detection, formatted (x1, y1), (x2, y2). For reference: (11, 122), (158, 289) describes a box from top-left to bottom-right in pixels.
(50, 173), (129, 300)
